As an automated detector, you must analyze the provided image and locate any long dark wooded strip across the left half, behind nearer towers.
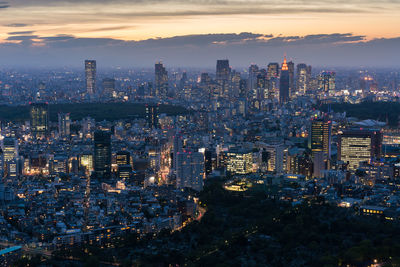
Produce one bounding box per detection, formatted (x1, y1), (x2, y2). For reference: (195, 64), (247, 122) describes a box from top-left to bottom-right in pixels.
(0, 103), (188, 122)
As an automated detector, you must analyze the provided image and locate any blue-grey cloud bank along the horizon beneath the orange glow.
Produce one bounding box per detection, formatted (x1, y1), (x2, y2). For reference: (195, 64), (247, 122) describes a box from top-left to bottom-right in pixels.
(0, 32), (400, 67)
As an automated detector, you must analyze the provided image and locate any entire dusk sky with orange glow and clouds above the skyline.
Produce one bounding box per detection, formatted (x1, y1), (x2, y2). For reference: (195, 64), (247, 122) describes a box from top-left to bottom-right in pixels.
(0, 0), (400, 67)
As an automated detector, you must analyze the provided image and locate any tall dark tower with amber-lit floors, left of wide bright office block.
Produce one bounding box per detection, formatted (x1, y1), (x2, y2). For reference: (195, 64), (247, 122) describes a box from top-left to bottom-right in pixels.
(310, 119), (332, 160)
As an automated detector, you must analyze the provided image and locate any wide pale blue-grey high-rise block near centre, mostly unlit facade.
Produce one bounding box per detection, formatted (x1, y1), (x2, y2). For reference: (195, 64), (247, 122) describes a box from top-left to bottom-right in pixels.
(176, 152), (205, 191)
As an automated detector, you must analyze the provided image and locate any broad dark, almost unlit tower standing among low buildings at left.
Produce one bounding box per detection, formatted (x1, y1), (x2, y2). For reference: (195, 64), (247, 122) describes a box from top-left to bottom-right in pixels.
(93, 130), (111, 179)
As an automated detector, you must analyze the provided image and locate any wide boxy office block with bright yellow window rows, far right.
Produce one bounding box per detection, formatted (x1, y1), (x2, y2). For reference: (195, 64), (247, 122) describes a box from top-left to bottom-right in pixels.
(338, 129), (382, 170)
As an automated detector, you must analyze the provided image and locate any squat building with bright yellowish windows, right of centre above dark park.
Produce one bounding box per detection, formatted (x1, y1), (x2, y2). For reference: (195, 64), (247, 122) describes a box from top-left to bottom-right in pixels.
(226, 149), (253, 174)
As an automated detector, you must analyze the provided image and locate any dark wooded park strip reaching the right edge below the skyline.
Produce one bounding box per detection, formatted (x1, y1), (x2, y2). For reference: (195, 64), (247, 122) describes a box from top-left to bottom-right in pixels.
(319, 102), (400, 127)
